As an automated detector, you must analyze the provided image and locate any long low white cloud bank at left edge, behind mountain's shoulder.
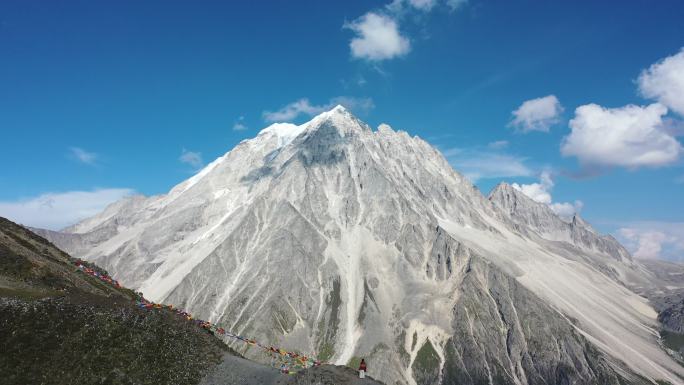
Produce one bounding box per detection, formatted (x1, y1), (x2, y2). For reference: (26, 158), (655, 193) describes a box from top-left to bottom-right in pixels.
(0, 188), (134, 230)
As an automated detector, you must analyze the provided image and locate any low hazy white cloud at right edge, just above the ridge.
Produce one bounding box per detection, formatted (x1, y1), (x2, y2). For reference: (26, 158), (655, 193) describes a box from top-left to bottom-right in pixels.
(616, 221), (684, 261)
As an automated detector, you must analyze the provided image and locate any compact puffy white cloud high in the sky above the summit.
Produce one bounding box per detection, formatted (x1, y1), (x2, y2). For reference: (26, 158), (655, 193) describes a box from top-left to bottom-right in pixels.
(344, 12), (411, 61)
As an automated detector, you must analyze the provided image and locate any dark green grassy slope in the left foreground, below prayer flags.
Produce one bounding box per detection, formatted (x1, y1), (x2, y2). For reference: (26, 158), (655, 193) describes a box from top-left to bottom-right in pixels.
(0, 218), (227, 384)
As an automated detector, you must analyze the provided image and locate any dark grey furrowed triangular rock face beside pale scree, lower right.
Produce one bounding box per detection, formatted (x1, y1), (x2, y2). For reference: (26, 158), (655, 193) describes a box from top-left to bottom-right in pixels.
(444, 258), (621, 385)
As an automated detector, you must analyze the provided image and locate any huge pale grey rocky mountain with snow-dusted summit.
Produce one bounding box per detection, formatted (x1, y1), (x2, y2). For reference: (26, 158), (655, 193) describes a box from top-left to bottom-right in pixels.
(37, 106), (684, 384)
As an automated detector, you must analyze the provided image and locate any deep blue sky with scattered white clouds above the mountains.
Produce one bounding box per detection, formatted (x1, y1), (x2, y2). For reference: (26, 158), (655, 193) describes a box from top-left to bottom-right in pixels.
(0, 0), (684, 259)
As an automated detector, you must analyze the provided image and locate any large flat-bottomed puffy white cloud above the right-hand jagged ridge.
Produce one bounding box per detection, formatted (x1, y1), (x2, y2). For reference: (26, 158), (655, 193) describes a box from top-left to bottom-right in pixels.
(561, 103), (682, 169)
